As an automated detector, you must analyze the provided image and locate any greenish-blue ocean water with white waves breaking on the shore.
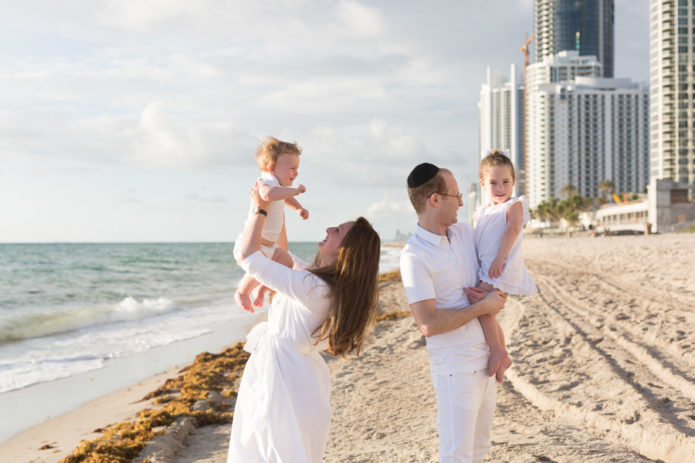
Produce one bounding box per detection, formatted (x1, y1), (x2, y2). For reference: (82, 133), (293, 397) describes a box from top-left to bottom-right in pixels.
(0, 243), (400, 393)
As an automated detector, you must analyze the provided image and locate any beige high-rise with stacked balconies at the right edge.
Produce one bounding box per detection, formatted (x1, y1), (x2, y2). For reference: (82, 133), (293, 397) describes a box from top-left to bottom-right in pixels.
(649, 0), (695, 184)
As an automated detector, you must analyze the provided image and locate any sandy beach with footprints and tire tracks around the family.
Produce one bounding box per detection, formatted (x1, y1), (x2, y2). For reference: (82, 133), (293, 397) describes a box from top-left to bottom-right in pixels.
(0, 234), (695, 463)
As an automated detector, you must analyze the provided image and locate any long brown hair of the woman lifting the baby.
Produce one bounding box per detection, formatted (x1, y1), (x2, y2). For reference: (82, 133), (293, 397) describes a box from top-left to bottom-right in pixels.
(310, 217), (381, 356)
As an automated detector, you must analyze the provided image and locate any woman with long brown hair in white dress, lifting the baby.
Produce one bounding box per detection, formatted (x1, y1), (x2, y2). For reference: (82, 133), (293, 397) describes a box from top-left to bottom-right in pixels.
(227, 183), (381, 463)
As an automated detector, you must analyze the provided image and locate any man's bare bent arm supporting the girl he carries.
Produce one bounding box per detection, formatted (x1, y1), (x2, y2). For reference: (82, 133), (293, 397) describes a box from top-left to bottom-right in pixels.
(410, 291), (507, 337)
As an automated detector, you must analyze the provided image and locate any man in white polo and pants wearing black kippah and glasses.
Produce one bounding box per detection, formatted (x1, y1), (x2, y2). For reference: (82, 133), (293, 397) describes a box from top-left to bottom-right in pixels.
(401, 163), (506, 463)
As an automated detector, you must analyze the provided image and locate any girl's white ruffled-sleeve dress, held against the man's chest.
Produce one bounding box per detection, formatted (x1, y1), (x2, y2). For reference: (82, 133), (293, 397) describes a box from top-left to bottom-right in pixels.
(473, 196), (536, 296)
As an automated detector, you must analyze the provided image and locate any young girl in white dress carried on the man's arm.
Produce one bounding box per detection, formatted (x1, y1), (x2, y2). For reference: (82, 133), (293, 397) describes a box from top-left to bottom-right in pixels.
(473, 150), (536, 381)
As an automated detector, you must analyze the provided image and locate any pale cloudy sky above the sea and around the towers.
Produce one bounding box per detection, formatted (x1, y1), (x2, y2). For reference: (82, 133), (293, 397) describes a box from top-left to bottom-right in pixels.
(0, 0), (649, 242)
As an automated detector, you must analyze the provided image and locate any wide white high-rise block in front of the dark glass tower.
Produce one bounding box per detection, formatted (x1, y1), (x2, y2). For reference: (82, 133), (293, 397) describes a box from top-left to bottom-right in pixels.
(526, 73), (649, 207)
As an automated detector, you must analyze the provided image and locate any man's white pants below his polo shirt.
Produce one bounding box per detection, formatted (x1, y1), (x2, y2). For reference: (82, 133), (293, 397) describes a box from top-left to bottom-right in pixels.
(432, 368), (497, 463)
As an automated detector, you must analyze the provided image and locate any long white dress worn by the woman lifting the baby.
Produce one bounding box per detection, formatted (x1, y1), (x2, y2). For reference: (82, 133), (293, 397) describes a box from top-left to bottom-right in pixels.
(227, 252), (331, 463)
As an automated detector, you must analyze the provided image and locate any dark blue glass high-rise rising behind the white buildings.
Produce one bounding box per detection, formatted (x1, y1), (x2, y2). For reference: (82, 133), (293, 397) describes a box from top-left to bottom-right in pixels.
(534, 0), (614, 77)
